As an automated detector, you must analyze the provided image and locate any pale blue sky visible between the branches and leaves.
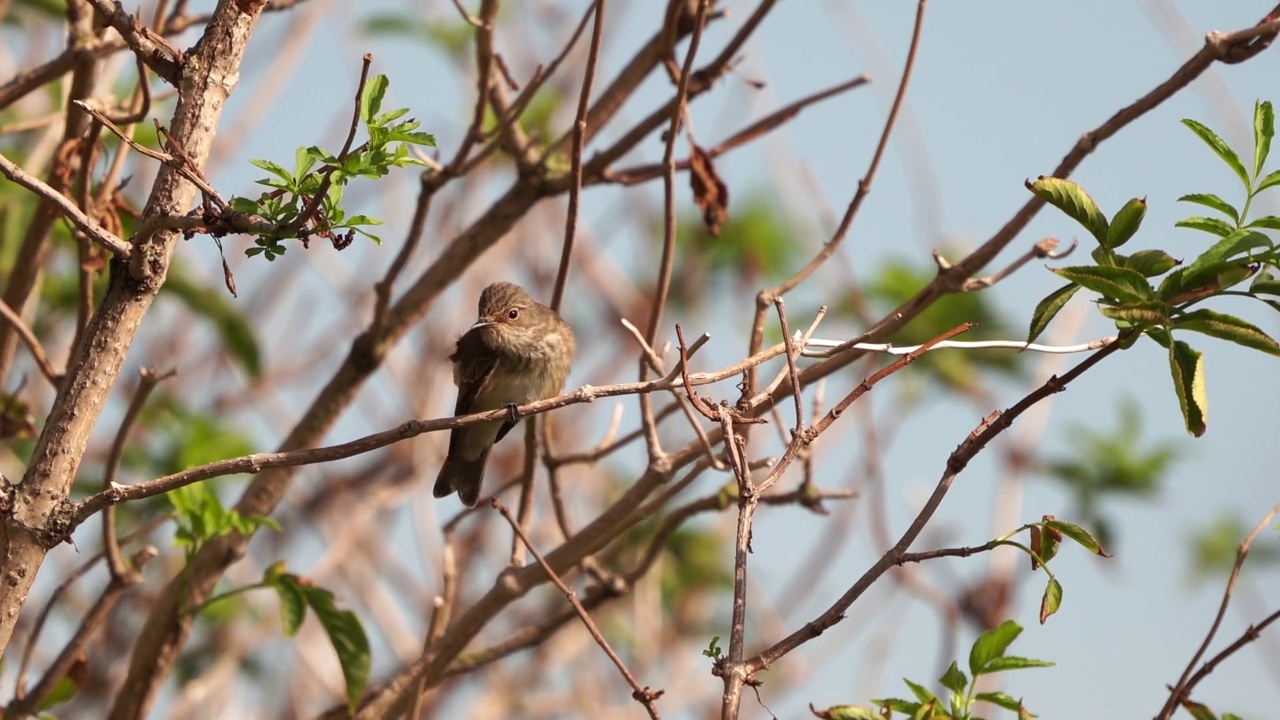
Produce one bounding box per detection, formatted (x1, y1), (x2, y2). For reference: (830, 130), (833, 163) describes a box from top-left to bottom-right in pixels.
(12, 0), (1280, 720)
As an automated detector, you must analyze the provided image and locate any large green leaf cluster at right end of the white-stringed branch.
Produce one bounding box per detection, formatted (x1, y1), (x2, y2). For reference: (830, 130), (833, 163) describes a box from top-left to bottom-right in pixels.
(1027, 102), (1280, 437)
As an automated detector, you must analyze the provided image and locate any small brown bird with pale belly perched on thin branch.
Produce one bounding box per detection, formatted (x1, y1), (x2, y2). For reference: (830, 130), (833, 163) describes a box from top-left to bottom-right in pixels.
(431, 283), (576, 507)
